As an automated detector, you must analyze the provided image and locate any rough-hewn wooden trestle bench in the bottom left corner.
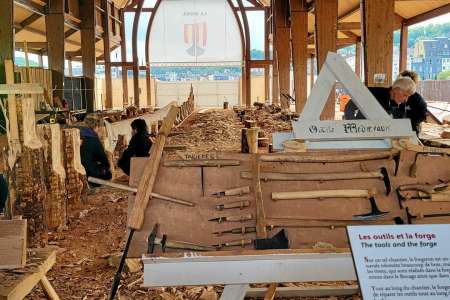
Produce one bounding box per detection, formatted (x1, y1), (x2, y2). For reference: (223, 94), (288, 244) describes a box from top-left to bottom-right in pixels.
(0, 248), (59, 300)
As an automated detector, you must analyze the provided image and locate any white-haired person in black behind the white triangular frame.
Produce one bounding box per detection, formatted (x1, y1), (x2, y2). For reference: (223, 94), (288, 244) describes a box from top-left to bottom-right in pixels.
(344, 77), (427, 132)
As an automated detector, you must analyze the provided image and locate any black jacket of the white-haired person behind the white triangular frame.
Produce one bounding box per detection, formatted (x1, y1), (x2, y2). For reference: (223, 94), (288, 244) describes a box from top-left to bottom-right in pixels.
(344, 87), (427, 132)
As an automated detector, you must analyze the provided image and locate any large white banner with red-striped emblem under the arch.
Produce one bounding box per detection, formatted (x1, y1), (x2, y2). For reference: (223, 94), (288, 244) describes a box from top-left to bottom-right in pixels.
(149, 0), (242, 65)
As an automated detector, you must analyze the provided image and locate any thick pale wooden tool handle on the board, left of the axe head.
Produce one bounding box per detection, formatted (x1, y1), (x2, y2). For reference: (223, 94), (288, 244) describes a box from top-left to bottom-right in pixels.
(272, 189), (373, 201)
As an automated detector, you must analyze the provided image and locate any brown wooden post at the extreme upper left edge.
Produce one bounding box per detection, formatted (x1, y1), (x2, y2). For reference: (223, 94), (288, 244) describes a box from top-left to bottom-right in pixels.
(0, 0), (14, 83)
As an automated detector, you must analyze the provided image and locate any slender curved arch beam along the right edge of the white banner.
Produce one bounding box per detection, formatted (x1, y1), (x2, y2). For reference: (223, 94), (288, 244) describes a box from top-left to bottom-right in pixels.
(237, 0), (252, 107)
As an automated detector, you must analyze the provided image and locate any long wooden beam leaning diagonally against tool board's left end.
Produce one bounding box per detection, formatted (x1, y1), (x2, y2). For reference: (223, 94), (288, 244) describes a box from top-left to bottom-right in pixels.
(128, 106), (179, 230)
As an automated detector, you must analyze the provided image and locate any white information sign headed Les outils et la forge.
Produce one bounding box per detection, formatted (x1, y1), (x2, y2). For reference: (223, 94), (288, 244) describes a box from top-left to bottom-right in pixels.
(347, 224), (450, 300)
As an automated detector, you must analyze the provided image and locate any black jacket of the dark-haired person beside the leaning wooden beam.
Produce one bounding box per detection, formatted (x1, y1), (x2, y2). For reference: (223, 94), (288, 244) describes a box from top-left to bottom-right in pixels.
(117, 132), (152, 176)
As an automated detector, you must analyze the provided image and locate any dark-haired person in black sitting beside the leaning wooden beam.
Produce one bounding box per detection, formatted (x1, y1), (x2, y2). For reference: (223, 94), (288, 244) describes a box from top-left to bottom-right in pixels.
(118, 119), (152, 176)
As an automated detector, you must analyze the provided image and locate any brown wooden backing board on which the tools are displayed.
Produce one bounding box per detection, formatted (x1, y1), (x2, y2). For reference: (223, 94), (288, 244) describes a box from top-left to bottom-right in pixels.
(129, 150), (450, 257)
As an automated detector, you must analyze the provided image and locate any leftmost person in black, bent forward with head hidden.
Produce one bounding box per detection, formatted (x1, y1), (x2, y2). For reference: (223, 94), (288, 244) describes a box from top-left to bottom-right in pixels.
(79, 127), (112, 180)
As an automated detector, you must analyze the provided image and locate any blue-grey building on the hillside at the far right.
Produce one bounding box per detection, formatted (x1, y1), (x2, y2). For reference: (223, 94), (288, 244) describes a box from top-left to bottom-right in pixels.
(411, 37), (450, 80)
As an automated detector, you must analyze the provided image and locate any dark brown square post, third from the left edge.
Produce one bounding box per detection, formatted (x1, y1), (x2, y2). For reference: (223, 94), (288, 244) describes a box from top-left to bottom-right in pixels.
(80, 0), (96, 112)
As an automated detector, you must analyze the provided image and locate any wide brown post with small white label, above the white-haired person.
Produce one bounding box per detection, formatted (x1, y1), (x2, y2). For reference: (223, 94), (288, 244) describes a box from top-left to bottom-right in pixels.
(361, 0), (394, 87)
